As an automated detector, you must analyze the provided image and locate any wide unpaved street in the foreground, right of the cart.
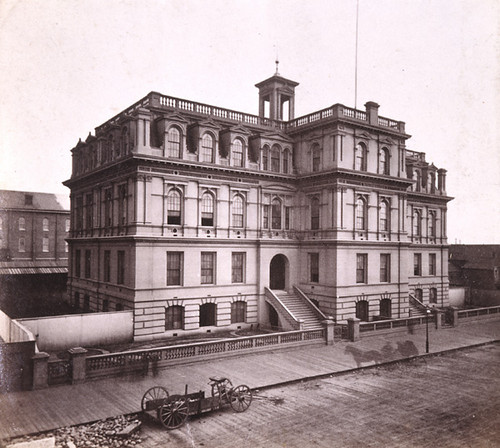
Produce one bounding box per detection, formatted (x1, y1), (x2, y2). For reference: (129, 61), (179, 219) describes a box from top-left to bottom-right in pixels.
(137, 344), (500, 448)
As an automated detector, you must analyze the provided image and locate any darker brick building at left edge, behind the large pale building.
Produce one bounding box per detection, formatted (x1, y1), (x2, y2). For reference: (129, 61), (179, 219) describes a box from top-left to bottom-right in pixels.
(0, 190), (70, 318)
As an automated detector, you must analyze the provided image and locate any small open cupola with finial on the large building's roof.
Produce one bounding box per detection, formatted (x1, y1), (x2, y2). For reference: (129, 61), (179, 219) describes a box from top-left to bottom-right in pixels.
(255, 61), (299, 121)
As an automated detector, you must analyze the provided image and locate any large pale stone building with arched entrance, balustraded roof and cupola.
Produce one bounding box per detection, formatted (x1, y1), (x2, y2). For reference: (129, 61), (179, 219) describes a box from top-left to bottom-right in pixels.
(65, 73), (451, 338)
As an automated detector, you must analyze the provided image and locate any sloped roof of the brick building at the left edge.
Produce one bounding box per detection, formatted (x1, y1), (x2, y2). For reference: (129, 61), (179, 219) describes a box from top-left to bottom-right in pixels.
(0, 190), (69, 211)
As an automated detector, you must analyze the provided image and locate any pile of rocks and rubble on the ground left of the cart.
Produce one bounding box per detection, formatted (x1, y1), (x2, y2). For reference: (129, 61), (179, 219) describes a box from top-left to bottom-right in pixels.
(8, 415), (142, 448)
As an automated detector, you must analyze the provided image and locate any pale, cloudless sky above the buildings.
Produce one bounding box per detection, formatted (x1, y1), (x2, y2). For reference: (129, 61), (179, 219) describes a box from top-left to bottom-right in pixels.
(0, 0), (500, 244)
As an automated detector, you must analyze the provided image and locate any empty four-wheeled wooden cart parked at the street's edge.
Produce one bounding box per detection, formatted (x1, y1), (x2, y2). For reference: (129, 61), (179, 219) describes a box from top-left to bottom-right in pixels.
(141, 377), (252, 429)
